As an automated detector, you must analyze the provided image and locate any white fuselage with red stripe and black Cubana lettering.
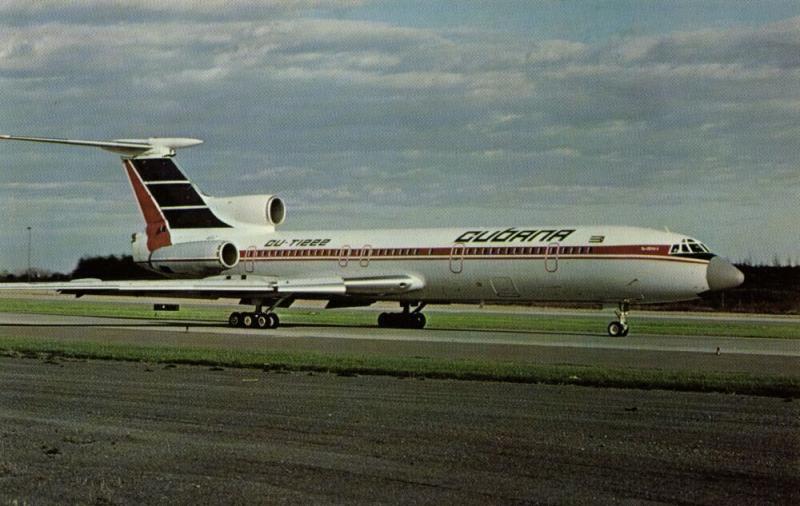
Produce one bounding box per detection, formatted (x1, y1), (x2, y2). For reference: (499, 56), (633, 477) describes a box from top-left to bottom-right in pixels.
(153, 226), (712, 303)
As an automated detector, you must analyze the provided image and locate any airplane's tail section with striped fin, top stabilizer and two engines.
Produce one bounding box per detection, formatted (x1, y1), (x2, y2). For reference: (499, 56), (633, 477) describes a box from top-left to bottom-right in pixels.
(0, 135), (286, 276)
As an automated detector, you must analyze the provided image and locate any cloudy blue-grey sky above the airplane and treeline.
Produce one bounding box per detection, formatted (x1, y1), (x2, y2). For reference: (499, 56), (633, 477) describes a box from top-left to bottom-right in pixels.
(0, 0), (800, 272)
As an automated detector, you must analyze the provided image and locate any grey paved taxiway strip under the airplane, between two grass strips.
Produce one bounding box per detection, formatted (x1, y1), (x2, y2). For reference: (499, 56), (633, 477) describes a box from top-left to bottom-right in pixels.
(0, 313), (800, 376)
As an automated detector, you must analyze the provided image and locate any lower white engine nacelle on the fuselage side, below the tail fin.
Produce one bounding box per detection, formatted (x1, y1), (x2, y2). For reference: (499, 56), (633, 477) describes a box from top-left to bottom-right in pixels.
(149, 241), (239, 276)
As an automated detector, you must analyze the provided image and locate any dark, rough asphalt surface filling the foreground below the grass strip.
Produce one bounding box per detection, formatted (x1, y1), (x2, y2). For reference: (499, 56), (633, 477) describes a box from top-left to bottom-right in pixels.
(0, 358), (800, 505)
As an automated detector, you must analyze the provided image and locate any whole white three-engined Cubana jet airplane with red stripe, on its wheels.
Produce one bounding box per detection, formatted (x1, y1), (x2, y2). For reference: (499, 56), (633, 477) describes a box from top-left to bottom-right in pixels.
(0, 135), (744, 336)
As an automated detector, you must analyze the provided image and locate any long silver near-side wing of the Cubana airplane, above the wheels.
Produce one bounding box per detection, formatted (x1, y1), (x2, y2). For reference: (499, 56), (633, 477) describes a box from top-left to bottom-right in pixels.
(0, 274), (425, 299)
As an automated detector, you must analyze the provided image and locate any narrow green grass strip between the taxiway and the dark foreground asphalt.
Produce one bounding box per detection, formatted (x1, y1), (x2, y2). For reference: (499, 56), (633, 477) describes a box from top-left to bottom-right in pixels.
(0, 337), (800, 398)
